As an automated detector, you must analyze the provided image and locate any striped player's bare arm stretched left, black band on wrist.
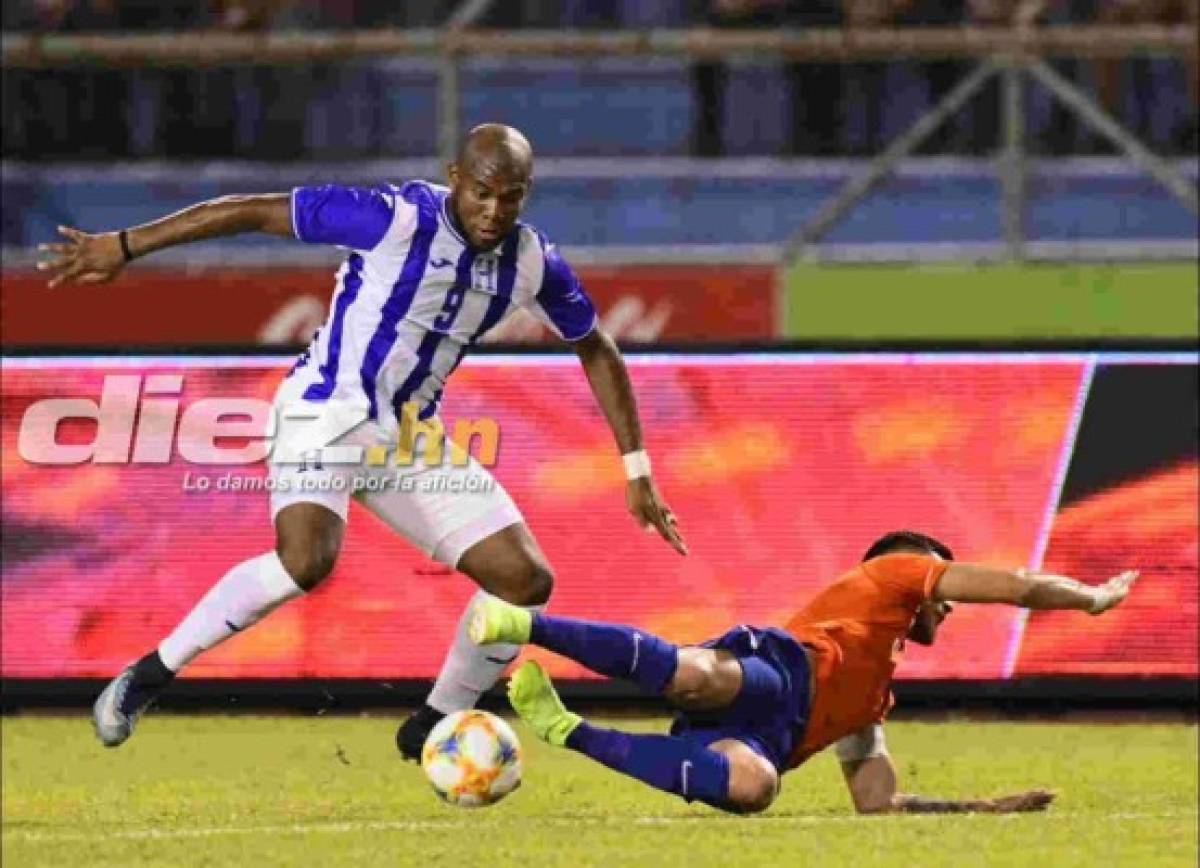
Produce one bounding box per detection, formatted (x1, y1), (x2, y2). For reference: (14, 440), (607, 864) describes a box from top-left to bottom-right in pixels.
(37, 193), (293, 287)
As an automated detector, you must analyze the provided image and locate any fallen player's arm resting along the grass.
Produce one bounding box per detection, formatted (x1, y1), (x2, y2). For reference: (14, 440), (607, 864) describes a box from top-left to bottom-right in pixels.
(835, 724), (1055, 814)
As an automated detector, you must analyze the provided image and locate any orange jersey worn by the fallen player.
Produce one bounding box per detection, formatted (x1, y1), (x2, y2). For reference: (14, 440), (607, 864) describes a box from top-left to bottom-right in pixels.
(786, 555), (949, 768)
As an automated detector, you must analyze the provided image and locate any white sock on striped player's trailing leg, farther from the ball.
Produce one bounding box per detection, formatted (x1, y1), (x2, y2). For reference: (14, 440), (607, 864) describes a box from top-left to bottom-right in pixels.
(158, 551), (304, 672)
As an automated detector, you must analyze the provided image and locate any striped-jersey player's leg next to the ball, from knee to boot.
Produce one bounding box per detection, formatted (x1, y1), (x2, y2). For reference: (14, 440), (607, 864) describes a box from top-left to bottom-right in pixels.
(396, 522), (554, 760)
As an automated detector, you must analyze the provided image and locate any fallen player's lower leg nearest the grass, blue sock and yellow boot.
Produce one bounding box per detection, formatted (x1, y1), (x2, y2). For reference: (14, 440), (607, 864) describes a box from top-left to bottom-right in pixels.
(509, 660), (779, 814)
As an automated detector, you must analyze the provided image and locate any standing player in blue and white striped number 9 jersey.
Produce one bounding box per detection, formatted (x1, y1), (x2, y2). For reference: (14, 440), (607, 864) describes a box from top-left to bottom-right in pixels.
(38, 124), (686, 759)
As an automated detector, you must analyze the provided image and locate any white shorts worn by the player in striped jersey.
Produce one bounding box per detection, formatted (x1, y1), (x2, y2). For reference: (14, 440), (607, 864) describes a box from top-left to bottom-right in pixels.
(270, 383), (524, 567)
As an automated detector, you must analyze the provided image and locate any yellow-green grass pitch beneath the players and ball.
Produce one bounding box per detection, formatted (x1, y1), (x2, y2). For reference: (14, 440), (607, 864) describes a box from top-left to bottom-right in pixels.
(2, 713), (1196, 868)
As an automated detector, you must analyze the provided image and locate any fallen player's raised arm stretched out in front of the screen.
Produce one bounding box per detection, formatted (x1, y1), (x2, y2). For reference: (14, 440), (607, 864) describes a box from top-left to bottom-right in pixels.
(934, 563), (1138, 615)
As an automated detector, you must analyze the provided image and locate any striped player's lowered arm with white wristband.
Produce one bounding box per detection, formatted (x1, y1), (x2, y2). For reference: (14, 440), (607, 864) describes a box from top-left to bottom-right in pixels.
(571, 328), (688, 555)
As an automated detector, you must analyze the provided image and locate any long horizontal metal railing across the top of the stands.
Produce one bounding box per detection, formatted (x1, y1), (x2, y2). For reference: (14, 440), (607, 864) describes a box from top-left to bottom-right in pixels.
(2, 26), (1196, 67)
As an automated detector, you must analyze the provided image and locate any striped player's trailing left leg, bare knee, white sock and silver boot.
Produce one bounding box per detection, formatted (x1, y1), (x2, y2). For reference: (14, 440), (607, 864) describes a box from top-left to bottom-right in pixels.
(92, 503), (346, 747)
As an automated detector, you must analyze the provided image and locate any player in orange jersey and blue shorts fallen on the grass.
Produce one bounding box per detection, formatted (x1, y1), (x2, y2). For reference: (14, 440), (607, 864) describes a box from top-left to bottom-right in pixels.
(469, 531), (1138, 813)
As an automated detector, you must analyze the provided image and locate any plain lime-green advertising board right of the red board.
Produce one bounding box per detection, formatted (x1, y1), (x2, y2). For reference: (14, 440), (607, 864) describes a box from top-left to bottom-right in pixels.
(787, 262), (1200, 340)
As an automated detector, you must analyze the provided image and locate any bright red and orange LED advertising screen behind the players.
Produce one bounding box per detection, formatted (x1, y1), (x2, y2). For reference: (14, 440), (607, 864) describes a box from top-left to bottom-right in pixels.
(2, 354), (1196, 680)
